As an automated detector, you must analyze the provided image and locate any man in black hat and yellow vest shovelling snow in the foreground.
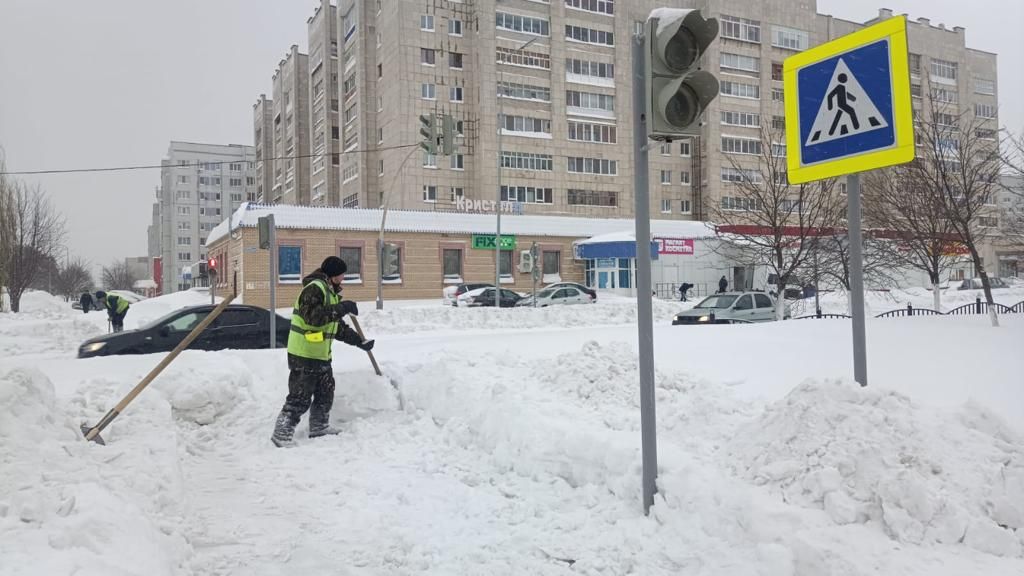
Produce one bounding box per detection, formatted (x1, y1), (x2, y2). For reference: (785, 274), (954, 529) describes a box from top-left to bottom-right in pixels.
(270, 256), (374, 448)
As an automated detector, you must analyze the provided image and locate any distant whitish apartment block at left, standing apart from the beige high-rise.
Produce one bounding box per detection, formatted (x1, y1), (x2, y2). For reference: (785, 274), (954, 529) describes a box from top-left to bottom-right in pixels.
(150, 141), (257, 294)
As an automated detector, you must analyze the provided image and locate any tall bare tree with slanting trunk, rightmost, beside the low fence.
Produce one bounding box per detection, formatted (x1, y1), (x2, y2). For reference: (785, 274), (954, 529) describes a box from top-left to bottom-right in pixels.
(906, 79), (1002, 326)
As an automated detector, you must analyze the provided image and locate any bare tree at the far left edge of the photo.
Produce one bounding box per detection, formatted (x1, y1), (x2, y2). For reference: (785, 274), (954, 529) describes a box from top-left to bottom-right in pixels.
(5, 179), (65, 312)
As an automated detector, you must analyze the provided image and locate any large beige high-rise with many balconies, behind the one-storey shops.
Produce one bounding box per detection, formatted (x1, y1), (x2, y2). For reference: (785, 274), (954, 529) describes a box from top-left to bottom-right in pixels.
(323, 0), (997, 219)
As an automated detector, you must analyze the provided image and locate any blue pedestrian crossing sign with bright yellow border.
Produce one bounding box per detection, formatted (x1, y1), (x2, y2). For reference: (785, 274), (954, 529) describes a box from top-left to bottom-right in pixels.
(782, 16), (914, 183)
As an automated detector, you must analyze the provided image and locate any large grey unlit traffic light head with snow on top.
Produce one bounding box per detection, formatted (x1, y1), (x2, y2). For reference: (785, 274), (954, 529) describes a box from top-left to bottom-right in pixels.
(644, 8), (718, 140)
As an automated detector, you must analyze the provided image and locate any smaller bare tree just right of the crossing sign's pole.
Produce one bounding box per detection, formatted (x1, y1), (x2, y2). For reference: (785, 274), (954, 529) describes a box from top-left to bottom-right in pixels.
(862, 166), (961, 312)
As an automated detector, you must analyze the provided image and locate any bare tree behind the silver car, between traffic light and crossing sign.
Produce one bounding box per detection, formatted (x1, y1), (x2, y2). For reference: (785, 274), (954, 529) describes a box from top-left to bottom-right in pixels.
(711, 126), (846, 320)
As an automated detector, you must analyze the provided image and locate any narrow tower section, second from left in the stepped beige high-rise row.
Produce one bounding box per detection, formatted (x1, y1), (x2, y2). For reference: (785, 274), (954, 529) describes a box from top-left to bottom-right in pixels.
(269, 44), (310, 204)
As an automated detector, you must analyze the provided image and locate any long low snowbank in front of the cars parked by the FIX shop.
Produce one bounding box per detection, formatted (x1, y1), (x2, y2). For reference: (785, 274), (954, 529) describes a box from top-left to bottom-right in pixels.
(359, 298), (692, 336)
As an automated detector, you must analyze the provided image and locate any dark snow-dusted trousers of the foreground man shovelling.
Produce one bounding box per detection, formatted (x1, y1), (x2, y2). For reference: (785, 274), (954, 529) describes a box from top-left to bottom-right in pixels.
(273, 364), (334, 440)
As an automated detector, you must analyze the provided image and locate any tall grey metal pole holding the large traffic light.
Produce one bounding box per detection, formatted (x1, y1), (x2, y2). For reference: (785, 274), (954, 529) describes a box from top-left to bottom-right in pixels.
(633, 34), (657, 515)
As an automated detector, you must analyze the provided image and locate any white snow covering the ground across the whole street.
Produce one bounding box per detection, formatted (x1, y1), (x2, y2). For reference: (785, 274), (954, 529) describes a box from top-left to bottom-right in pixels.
(0, 290), (1024, 576)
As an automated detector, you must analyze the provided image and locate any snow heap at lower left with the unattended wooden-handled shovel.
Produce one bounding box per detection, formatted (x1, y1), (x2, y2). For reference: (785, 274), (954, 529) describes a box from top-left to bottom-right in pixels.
(0, 369), (187, 576)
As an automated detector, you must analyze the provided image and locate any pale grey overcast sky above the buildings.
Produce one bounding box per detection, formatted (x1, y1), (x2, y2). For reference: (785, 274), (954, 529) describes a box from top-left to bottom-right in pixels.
(0, 0), (1024, 264)
